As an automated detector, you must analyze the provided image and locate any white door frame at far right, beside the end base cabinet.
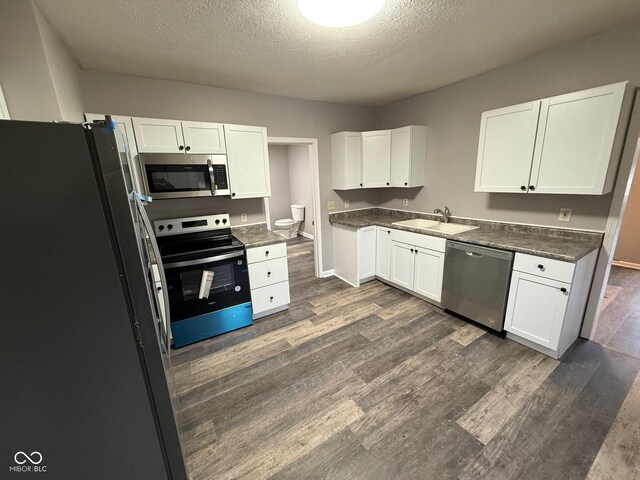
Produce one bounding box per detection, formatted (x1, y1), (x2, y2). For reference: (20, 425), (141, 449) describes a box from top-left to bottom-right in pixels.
(580, 89), (640, 340)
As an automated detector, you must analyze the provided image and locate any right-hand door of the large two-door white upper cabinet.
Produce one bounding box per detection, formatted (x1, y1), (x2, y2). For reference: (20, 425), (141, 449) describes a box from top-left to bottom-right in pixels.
(530, 83), (626, 195)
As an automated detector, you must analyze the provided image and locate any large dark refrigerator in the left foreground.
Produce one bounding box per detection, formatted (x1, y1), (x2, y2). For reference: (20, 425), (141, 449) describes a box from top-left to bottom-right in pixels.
(0, 120), (187, 480)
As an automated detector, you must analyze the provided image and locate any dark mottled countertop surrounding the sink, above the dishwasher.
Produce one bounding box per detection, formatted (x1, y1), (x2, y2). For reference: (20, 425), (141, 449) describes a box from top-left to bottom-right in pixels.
(329, 208), (603, 262)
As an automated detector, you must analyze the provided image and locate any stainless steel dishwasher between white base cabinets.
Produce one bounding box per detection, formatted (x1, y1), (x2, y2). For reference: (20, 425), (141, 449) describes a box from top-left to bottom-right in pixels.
(442, 240), (513, 332)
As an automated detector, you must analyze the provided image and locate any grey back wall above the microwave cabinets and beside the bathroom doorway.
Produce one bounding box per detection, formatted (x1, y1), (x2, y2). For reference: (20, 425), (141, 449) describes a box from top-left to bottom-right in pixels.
(82, 70), (378, 270)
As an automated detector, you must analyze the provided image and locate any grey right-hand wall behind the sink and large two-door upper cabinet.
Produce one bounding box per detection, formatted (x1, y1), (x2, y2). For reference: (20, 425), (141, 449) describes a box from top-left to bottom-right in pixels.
(376, 23), (640, 230)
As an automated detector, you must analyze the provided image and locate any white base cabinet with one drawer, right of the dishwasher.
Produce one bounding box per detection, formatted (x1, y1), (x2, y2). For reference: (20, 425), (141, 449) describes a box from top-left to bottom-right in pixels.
(504, 250), (598, 358)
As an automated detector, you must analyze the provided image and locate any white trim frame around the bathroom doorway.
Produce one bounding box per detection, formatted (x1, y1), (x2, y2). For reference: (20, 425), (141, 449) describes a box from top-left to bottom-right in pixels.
(263, 137), (326, 278)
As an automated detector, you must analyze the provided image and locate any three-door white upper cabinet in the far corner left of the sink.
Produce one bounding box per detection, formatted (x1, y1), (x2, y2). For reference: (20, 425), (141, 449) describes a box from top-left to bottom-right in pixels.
(331, 125), (427, 190)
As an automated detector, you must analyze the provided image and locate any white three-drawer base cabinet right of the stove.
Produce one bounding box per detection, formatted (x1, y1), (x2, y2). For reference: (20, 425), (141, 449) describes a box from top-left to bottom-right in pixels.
(247, 243), (291, 320)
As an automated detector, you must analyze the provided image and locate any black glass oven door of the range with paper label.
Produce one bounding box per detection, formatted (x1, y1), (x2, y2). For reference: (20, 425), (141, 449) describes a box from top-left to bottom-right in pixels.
(165, 258), (251, 322)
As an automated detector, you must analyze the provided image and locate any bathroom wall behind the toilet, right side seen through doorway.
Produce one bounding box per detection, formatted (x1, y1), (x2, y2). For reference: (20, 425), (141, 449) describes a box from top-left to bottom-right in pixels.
(288, 145), (315, 235)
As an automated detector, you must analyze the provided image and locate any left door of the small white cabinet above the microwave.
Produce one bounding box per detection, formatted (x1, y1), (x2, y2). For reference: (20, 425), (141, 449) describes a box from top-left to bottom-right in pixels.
(132, 117), (184, 153)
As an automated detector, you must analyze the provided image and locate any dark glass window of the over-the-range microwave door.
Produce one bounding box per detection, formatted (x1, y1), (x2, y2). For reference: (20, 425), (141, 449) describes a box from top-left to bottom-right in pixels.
(144, 165), (211, 193)
